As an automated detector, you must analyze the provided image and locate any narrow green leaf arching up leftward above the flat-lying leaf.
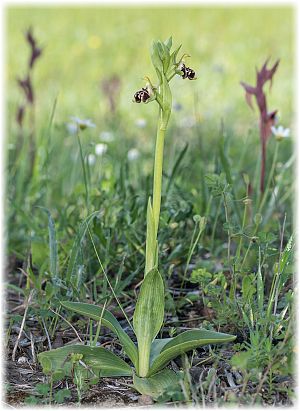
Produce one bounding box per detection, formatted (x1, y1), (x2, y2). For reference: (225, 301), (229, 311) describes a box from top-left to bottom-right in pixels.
(61, 301), (138, 369)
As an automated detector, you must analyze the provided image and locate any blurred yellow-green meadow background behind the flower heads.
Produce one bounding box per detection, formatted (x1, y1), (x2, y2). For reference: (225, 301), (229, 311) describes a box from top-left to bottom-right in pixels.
(6, 6), (295, 134)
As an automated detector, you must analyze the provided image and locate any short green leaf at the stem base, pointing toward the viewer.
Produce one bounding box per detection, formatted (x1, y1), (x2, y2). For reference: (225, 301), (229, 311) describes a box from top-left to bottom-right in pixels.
(133, 370), (180, 399)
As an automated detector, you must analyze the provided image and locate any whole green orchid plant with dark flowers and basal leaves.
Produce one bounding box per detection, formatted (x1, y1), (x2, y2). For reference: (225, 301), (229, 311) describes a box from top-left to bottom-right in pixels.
(39, 38), (236, 398)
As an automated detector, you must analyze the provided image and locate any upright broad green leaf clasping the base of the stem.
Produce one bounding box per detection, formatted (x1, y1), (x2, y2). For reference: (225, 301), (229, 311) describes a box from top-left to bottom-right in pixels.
(133, 268), (165, 377)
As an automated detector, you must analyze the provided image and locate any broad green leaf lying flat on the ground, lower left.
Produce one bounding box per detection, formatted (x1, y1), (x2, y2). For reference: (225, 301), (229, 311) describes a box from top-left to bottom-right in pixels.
(38, 345), (132, 379)
